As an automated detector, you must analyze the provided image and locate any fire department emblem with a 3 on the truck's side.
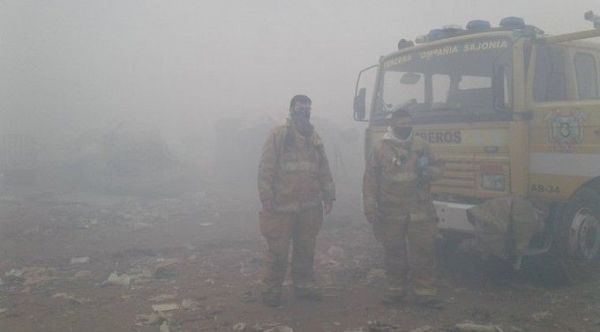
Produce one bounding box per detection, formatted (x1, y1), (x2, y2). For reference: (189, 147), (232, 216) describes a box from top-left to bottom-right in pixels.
(549, 112), (583, 152)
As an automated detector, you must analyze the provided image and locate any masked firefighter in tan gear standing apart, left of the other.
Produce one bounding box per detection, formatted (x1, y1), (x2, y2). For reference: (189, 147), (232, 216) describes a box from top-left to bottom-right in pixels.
(258, 95), (335, 306)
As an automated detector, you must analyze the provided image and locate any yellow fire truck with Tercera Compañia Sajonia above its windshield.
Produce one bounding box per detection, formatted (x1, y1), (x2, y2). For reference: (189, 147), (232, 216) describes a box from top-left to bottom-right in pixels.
(354, 12), (600, 274)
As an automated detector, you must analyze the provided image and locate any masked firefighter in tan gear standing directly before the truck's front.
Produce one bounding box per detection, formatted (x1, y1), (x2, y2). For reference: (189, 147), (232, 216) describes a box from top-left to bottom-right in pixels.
(363, 110), (439, 303)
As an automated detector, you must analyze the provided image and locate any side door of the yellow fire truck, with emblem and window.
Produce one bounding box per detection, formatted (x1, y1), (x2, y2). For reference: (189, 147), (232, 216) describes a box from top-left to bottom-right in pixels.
(528, 44), (600, 201)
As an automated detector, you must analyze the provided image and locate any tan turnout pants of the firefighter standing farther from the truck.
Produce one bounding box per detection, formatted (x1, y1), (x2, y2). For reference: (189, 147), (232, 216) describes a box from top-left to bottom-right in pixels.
(260, 205), (323, 292)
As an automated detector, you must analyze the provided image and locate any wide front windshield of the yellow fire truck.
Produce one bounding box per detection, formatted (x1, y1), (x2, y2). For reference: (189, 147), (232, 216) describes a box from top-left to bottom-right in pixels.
(371, 37), (512, 120)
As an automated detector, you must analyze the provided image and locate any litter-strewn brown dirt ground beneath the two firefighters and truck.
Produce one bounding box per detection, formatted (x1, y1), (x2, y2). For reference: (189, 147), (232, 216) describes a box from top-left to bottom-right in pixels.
(0, 185), (600, 332)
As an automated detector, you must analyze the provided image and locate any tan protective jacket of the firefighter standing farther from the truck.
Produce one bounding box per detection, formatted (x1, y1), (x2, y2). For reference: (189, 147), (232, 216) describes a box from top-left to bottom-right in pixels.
(258, 120), (335, 212)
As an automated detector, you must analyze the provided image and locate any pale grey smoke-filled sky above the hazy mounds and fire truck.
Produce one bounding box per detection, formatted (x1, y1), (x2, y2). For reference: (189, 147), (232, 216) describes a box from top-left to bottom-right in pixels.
(0, 0), (600, 140)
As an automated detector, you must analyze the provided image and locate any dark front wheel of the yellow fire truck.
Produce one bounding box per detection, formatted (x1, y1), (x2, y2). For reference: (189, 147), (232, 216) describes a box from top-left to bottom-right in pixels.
(556, 188), (600, 282)
